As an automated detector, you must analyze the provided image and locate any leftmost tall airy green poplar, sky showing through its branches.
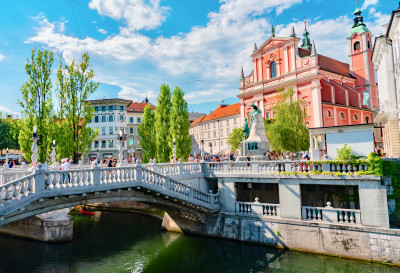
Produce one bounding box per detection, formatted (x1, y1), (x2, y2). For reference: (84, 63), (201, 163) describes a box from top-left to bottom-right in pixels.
(18, 48), (54, 162)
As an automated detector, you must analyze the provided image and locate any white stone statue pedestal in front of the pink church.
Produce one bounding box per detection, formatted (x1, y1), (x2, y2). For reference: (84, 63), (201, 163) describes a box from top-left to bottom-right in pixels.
(238, 109), (269, 161)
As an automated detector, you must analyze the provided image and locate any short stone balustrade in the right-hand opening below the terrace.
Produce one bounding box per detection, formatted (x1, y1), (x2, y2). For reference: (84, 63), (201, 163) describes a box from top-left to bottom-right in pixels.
(301, 206), (361, 225)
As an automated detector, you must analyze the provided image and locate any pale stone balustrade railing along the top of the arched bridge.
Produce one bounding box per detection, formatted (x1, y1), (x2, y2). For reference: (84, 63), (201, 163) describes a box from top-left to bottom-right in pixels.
(0, 164), (219, 211)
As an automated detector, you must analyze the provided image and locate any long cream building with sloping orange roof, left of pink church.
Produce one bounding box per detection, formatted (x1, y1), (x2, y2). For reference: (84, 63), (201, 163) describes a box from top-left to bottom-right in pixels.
(189, 103), (243, 155)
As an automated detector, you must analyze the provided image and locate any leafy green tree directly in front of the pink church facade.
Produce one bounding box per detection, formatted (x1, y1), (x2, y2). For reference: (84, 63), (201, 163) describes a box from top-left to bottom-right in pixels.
(265, 87), (310, 152)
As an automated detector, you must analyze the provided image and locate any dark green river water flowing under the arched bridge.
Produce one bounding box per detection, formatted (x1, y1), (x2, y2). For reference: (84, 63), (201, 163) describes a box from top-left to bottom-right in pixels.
(0, 212), (400, 273)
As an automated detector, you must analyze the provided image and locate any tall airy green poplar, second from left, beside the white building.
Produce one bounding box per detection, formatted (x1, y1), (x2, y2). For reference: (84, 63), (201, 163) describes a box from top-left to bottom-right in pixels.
(55, 53), (99, 162)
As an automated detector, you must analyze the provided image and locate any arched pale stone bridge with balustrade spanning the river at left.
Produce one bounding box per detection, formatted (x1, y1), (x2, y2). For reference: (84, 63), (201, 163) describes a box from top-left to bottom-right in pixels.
(0, 164), (219, 226)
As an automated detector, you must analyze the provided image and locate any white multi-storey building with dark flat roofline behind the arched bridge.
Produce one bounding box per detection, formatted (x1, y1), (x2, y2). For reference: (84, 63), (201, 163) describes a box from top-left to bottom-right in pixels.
(86, 99), (132, 160)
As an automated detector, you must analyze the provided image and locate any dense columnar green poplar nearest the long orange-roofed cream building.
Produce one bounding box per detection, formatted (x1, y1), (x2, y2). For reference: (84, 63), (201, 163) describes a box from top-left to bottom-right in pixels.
(169, 86), (192, 161)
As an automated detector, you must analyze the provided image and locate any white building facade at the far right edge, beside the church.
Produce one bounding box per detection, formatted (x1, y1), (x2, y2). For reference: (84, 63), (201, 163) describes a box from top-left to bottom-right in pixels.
(372, 6), (400, 157)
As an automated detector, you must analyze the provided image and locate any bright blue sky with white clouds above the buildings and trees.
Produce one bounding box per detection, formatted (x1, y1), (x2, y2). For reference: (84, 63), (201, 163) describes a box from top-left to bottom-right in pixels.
(0, 0), (398, 113)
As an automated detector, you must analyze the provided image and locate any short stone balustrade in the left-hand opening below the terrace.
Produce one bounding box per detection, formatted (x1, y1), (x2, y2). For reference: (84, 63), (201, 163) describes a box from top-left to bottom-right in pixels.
(235, 202), (280, 217)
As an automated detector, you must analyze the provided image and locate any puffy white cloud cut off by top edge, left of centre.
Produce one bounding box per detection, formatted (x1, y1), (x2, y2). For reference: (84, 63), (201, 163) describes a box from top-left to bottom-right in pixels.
(89, 0), (168, 30)
